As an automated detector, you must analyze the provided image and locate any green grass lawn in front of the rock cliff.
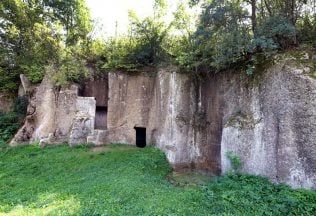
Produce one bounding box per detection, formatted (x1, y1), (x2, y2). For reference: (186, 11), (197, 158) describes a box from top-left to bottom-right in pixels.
(0, 145), (316, 216)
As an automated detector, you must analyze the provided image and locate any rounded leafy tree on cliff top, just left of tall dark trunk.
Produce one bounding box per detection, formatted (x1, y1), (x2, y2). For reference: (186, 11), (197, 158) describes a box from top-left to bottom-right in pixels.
(195, 0), (250, 69)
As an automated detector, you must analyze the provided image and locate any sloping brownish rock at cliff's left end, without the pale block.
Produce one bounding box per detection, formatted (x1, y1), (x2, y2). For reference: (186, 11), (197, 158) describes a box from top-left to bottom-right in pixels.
(10, 76), (78, 146)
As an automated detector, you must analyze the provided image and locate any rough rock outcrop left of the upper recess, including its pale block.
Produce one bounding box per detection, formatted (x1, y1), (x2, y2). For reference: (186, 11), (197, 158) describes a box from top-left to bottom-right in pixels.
(10, 76), (95, 146)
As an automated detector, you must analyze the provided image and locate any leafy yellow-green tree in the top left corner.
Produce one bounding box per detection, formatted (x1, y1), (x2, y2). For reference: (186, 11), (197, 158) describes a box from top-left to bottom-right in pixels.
(0, 0), (91, 92)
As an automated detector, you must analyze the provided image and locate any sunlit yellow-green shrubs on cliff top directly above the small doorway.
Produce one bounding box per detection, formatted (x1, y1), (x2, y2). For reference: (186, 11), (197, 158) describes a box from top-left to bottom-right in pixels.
(104, 0), (171, 71)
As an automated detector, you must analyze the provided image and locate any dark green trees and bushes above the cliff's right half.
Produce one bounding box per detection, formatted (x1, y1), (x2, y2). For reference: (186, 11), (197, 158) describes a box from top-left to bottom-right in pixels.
(173, 0), (315, 74)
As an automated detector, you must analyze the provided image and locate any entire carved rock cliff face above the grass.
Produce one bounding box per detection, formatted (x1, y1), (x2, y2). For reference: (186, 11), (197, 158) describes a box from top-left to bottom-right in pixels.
(12, 57), (316, 189)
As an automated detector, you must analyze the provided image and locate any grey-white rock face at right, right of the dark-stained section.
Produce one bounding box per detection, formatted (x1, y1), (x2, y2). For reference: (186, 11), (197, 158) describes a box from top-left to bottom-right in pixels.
(221, 60), (316, 188)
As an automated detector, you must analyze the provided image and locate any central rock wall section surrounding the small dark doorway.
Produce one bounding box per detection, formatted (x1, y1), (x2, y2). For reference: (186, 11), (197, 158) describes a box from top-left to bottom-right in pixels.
(107, 70), (220, 173)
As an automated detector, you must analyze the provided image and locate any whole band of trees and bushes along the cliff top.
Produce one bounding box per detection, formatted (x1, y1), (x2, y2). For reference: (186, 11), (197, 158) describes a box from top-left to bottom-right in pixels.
(0, 0), (316, 94)
